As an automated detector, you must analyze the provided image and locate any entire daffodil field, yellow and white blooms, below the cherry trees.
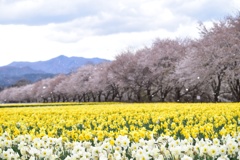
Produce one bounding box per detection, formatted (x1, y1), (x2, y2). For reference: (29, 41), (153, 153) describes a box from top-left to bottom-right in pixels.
(0, 103), (240, 160)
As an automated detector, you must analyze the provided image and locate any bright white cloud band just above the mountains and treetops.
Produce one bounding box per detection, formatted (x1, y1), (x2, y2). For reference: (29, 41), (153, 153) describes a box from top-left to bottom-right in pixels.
(0, 20), (200, 64)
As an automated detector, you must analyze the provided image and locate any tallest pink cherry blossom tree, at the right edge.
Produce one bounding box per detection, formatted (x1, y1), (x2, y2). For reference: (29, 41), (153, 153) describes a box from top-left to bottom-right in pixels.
(174, 13), (240, 102)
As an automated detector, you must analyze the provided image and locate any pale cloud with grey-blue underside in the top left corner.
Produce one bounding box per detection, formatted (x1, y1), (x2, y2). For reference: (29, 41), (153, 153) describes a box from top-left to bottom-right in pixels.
(0, 0), (86, 19)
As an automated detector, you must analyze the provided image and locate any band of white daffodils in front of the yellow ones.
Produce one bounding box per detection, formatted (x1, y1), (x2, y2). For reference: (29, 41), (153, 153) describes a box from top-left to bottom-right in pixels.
(0, 132), (240, 160)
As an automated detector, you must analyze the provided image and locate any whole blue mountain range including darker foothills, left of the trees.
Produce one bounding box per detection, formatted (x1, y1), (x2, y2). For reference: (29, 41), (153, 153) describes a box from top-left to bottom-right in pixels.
(0, 55), (109, 87)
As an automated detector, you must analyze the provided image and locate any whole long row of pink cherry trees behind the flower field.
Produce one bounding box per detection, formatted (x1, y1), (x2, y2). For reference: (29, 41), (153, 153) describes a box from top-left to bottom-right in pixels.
(0, 15), (240, 102)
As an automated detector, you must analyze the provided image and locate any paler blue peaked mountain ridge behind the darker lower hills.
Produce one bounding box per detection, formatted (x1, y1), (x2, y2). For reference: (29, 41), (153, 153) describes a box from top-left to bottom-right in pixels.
(8, 55), (108, 74)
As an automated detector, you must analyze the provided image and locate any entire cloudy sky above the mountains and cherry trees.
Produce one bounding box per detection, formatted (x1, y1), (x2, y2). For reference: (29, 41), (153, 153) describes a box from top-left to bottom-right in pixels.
(0, 0), (240, 66)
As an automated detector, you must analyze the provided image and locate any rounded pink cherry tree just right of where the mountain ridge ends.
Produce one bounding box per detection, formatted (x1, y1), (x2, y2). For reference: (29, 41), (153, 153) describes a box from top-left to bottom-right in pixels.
(111, 50), (151, 102)
